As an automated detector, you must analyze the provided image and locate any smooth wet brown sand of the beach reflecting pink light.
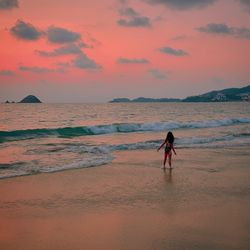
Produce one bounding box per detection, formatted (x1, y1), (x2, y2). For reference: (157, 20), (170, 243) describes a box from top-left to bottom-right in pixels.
(0, 148), (250, 249)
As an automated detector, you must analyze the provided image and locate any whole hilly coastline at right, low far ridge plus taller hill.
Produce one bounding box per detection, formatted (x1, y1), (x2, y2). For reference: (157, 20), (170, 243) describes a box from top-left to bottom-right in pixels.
(110, 85), (250, 103)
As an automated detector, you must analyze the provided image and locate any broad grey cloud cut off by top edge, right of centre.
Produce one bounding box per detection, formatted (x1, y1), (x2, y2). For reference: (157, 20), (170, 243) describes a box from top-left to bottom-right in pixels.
(145, 0), (217, 10)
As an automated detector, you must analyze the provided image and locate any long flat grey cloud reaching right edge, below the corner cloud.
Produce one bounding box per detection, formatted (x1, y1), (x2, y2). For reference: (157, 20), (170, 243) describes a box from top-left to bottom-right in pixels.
(197, 23), (250, 39)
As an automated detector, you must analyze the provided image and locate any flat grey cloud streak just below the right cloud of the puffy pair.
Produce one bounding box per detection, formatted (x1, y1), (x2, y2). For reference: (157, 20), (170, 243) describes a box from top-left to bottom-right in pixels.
(36, 43), (82, 57)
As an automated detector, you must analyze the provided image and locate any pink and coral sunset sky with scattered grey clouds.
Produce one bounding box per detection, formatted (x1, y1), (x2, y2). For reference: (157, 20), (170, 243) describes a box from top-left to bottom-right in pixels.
(0, 0), (250, 102)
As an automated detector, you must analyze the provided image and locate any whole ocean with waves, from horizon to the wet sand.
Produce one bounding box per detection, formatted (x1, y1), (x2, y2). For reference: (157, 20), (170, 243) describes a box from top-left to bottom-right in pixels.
(0, 102), (250, 178)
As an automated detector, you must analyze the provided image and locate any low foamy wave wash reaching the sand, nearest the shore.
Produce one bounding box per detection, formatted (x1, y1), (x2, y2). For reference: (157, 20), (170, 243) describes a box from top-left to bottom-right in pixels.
(0, 133), (250, 179)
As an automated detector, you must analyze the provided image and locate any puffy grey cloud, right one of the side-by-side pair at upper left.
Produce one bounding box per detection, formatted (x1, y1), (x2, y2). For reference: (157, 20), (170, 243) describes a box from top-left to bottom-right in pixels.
(47, 26), (81, 43)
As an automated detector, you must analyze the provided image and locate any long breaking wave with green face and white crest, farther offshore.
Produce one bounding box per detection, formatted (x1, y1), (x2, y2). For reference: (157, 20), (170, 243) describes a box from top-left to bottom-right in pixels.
(0, 118), (250, 143)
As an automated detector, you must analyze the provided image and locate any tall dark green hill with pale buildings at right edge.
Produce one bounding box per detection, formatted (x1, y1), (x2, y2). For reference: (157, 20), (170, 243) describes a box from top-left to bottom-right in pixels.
(182, 85), (250, 102)
